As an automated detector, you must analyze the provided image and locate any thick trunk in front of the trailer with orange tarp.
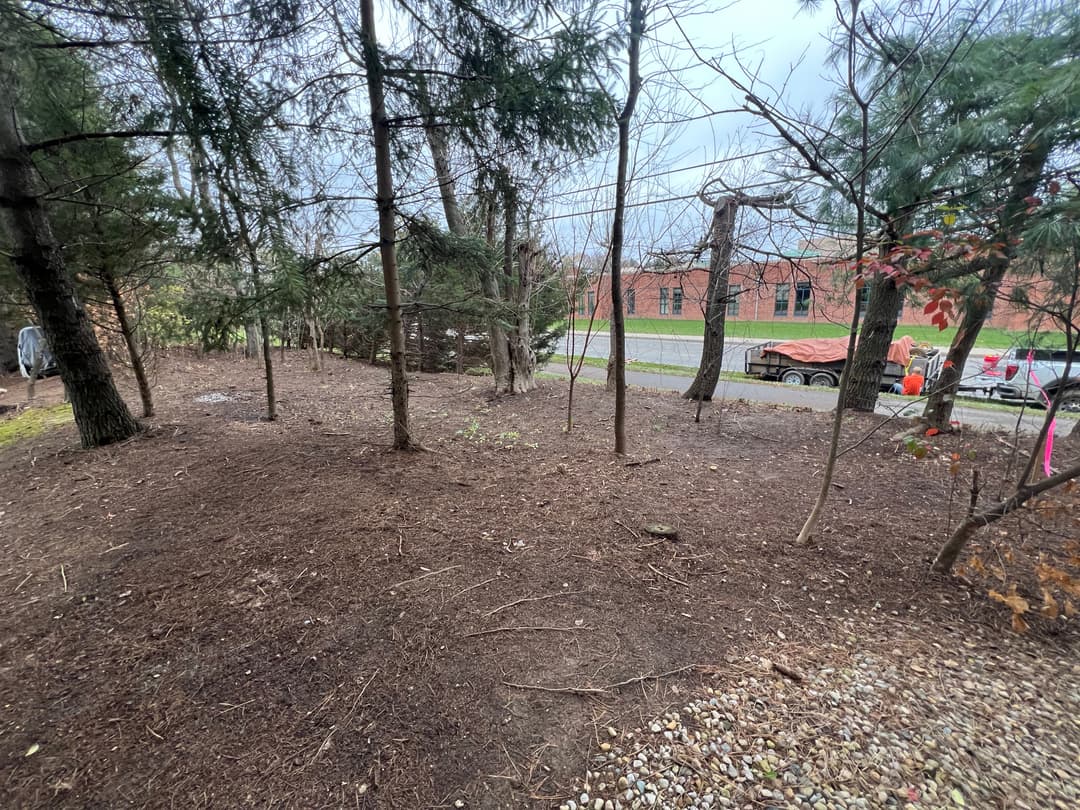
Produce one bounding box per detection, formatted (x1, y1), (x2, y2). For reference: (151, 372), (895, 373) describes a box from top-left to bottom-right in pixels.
(843, 273), (904, 411)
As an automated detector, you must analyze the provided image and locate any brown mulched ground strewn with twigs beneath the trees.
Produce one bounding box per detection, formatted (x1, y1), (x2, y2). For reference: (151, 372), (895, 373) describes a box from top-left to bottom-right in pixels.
(0, 353), (1076, 808)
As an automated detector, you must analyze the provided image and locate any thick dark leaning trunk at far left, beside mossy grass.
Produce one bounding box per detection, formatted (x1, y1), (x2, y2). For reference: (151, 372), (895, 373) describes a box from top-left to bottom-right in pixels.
(0, 81), (139, 447)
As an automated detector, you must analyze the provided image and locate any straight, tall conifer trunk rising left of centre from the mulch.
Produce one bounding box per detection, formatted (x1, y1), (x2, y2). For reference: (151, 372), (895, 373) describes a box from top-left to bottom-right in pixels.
(360, 0), (413, 450)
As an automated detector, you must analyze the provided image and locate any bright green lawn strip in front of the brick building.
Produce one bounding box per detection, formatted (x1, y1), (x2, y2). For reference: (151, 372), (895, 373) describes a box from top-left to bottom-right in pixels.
(565, 318), (1055, 349)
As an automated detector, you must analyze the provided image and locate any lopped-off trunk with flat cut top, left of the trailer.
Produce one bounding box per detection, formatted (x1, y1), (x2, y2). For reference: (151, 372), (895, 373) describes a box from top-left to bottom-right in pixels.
(683, 197), (739, 401)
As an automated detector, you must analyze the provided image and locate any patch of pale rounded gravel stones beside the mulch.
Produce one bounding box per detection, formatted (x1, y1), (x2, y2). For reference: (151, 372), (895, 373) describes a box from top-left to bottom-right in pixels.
(561, 630), (1080, 810)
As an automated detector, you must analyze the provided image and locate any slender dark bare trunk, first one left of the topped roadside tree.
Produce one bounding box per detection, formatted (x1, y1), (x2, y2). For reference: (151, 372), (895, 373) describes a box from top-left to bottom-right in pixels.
(611, 0), (645, 455)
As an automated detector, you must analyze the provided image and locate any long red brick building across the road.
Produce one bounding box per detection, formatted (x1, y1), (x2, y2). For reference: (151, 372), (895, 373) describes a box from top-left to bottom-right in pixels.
(577, 259), (1030, 332)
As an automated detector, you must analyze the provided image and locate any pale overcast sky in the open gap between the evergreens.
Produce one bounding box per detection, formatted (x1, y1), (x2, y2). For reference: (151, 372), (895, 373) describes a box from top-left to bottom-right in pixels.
(539, 0), (834, 261)
